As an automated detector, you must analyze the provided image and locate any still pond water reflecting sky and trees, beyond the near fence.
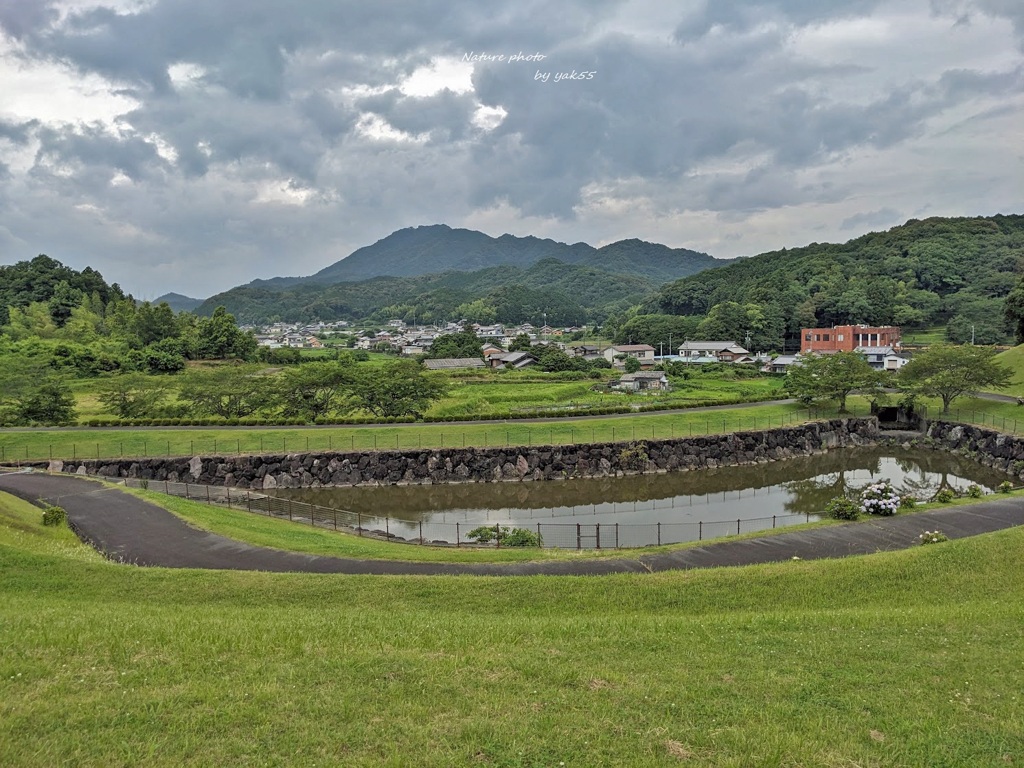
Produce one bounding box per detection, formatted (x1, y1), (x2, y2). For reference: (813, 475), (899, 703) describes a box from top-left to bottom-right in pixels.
(276, 449), (1005, 529)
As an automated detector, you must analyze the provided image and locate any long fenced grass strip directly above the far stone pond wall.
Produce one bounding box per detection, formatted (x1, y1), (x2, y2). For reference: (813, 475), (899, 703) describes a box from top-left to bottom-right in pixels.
(0, 404), (843, 463)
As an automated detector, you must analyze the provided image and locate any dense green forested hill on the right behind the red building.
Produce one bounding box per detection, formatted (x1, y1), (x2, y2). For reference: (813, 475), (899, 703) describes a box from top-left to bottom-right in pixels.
(648, 215), (1024, 344)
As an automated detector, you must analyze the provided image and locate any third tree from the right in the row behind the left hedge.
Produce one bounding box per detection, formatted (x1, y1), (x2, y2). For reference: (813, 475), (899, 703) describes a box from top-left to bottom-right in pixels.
(178, 365), (273, 419)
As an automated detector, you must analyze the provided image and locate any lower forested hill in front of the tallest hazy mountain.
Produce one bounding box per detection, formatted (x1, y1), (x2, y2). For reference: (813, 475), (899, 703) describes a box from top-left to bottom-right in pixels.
(197, 259), (657, 325)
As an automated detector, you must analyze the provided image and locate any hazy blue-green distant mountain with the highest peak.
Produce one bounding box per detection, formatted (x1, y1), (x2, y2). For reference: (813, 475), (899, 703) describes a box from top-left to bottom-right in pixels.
(250, 224), (721, 289)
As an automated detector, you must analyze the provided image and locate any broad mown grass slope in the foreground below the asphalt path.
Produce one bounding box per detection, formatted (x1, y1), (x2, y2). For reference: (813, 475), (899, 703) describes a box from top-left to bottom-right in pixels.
(0, 489), (1024, 766)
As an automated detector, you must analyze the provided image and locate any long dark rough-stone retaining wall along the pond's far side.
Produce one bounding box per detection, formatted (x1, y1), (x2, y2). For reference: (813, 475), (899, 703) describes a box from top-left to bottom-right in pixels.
(40, 417), (879, 489)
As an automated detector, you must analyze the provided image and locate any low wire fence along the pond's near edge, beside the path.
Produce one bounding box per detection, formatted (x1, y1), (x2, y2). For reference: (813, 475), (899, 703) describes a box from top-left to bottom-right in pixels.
(119, 478), (818, 550)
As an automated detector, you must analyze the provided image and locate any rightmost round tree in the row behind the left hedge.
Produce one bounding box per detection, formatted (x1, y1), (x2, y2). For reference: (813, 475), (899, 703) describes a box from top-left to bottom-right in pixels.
(351, 360), (446, 417)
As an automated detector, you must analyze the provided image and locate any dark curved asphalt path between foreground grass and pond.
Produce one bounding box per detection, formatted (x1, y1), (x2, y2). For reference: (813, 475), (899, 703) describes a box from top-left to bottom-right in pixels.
(0, 472), (1024, 575)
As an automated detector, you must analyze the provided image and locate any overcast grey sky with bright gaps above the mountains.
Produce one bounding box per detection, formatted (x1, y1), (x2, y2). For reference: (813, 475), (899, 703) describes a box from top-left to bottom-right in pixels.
(0, 0), (1024, 298)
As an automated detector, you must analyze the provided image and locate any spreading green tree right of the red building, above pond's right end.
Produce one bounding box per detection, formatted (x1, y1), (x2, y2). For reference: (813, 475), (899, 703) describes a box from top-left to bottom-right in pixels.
(899, 344), (1013, 414)
